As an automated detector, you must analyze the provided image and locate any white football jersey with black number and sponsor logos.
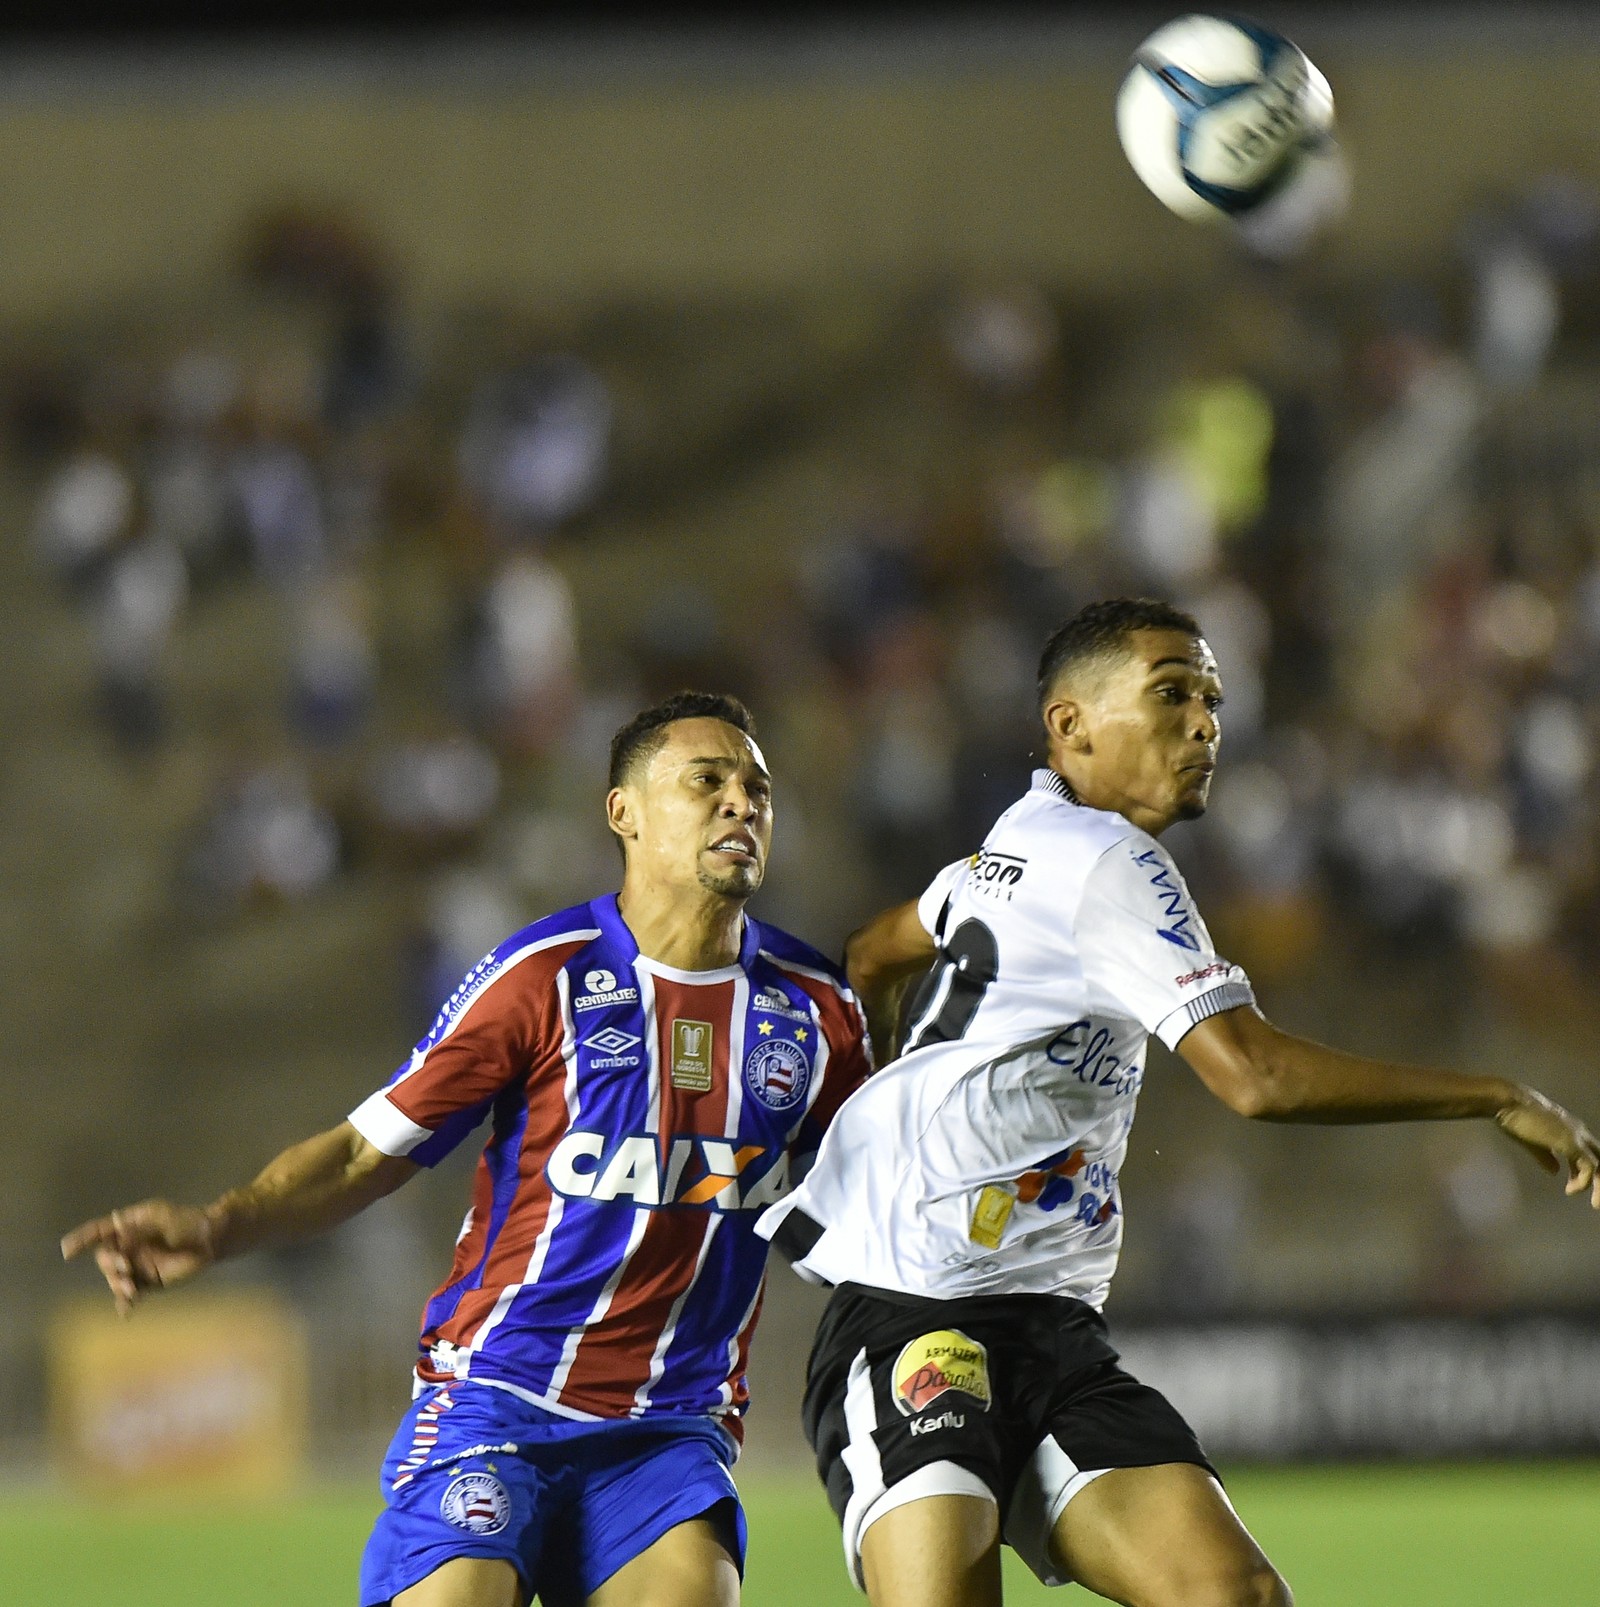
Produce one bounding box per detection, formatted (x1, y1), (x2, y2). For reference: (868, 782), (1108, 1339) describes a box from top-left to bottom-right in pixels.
(757, 770), (1255, 1308)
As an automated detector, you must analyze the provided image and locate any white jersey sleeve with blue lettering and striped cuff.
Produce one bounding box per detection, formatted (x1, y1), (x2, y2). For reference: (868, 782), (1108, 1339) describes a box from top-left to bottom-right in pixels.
(1076, 836), (1255, 1049)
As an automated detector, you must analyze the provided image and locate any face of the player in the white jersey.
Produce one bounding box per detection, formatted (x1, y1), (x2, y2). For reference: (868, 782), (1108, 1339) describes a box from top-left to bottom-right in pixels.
(1060, 630), (1222, 832)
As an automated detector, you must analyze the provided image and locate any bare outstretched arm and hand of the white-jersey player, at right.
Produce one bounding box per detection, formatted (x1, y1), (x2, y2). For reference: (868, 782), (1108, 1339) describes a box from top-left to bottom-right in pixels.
(1178, 1006), (1600, 1210)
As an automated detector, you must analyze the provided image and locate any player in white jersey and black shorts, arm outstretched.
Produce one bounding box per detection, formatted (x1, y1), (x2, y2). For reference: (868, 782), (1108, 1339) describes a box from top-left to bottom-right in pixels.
(758, 599), (1600, 1607)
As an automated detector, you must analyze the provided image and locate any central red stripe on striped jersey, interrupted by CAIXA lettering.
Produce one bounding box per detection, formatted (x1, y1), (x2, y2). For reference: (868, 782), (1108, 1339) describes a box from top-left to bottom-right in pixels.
(561, 977), (737, 1413)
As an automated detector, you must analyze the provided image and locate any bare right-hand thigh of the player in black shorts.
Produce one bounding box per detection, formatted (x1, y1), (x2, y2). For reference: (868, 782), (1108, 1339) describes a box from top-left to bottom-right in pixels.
(1051, 1462), (1290, 1607)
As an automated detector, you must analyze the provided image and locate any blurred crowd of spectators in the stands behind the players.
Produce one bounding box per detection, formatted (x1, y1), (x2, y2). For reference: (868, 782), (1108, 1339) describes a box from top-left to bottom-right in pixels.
(10, 177), (1600, 1302)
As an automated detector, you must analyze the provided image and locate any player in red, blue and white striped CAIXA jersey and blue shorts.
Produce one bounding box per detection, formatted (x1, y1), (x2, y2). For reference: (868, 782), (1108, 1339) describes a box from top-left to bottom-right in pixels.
(63, 693), (869, 1607)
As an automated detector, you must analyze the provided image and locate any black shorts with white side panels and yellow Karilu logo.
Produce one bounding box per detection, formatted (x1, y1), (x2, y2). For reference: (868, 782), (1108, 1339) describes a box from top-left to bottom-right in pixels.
(805, 1284), (1214, 1585)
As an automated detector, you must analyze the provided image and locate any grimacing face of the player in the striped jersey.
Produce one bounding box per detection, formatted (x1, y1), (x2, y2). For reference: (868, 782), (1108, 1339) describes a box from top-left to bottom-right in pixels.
(623, 718), (773, 898)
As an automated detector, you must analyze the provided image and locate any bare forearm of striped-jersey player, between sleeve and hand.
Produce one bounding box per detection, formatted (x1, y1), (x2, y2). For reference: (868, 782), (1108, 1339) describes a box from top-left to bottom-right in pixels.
(206, 1122), (416, 1260)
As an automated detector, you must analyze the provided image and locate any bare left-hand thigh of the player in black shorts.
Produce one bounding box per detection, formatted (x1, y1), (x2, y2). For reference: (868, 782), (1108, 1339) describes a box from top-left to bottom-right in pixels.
(861, 1495), (1001, 1607)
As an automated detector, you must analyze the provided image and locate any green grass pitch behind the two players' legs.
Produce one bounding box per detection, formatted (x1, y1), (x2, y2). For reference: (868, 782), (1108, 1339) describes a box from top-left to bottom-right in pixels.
(0, 1464), (1600, 1607)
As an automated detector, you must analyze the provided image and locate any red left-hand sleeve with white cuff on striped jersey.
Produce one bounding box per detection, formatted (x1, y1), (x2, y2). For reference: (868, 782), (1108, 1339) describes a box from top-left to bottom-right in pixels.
(349, 955), (556, 1167)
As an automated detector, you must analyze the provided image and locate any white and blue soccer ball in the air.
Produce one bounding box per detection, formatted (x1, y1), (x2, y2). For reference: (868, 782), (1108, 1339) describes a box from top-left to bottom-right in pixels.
(1116, 16), (1333, 220)
